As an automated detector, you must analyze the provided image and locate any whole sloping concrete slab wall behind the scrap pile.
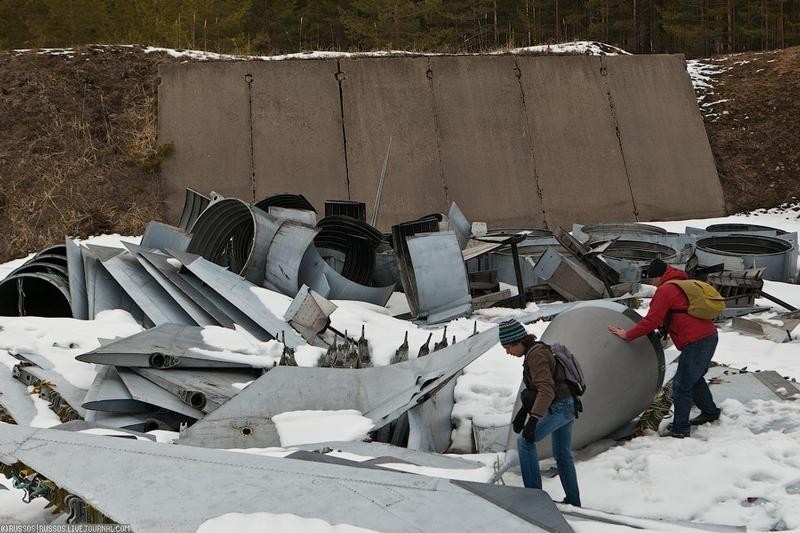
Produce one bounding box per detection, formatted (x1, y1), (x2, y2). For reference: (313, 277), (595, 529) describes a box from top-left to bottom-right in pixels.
(159, 56), (724, 230)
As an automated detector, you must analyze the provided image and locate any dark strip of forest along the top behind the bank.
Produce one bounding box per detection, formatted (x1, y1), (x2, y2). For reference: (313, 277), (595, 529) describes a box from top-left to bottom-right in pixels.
(0, 0), (800, 58)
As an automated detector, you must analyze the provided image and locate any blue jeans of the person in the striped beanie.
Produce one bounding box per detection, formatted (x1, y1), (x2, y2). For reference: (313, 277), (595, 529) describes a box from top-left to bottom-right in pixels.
(517, 398), (581, 506)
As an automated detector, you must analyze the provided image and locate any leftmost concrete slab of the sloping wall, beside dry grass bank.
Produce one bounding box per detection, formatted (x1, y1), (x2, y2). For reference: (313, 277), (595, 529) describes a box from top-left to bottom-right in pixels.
(158, 62), (253, 223)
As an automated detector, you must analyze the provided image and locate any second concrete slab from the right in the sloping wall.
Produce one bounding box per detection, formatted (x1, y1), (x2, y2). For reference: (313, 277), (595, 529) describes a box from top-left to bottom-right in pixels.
(517, 56), (634, 227)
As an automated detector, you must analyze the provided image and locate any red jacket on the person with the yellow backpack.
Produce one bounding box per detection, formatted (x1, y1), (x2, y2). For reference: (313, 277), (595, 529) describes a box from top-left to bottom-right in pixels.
(625, 266), (717, 350)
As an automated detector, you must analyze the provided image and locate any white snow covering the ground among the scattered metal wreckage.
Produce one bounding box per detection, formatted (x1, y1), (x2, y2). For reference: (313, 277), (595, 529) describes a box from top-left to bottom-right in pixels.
(0, 207), (800, 532)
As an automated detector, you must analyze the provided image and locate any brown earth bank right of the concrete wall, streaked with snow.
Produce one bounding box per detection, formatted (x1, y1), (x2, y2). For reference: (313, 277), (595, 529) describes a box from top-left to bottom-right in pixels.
(705, 47), (800, 213)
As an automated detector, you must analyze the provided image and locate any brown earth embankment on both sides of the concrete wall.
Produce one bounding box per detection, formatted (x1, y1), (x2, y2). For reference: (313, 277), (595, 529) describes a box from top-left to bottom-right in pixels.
(0, 46), (800, 262)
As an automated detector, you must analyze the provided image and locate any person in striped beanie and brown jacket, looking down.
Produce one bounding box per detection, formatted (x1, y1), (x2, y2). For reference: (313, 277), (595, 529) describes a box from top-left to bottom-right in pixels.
(499, 318), (581, 507)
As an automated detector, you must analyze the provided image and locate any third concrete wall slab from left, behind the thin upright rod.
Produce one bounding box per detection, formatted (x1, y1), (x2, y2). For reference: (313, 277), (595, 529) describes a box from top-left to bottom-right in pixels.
(340, 57), (448, 230)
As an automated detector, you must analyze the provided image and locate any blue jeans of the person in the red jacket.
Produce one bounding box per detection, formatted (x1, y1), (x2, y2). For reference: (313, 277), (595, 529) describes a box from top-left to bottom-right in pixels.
(672, 334), (720, 433)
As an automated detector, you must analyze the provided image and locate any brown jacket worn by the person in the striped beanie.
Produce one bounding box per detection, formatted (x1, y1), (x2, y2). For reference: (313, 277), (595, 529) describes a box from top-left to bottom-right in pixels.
(522, 343), (572, 418)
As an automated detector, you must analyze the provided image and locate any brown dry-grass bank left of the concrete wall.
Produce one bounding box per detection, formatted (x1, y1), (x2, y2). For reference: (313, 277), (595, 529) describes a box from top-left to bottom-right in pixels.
(0, 47), (174, 262)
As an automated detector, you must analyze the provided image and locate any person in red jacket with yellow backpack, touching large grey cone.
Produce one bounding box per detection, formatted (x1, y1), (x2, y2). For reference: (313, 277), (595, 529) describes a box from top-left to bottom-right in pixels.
(608, 259), (721, 438)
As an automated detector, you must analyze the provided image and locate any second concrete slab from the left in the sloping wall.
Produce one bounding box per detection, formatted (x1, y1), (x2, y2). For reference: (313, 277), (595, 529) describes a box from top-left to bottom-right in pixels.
(251, 60), (348, 213)
